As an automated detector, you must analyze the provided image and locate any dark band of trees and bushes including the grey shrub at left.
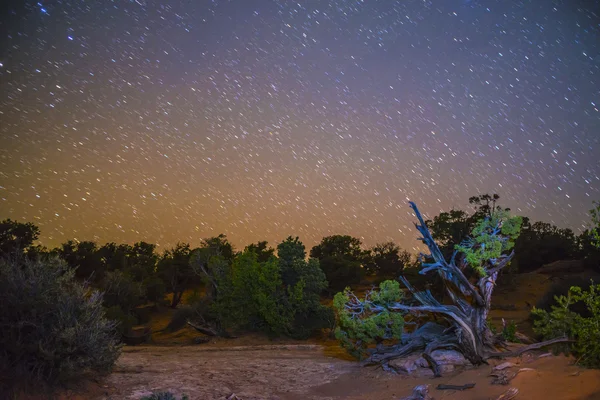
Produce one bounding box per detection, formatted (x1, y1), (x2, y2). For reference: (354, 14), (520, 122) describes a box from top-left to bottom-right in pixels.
(0, 194), (600, 394)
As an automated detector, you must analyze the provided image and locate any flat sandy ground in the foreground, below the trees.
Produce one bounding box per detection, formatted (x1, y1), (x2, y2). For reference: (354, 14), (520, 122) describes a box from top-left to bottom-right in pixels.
(65, 345), (600, 400)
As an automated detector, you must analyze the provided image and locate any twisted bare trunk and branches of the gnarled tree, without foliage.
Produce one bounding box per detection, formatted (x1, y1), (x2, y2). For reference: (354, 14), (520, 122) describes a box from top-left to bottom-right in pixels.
(346, 202), (566, 376)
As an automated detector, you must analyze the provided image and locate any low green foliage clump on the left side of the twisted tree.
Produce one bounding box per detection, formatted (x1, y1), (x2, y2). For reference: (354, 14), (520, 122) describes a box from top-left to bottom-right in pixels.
(333, 281), (404, 359)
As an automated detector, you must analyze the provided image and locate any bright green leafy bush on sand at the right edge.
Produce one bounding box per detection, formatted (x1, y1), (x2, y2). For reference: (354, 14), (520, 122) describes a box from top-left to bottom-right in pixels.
(532, 284), (600, 368)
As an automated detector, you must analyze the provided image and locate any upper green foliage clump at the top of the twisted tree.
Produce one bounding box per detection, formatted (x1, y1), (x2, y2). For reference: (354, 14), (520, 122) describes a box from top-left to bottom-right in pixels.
(456, 210), (522, 276)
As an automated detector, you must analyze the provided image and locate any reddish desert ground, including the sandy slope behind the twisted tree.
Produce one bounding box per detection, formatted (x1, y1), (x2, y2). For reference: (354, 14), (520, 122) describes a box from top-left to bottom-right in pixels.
(55, 262), (600, 400)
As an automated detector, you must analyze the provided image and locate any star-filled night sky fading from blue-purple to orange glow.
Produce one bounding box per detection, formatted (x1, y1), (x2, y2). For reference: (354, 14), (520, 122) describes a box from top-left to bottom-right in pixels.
(0, 0), (600, 250)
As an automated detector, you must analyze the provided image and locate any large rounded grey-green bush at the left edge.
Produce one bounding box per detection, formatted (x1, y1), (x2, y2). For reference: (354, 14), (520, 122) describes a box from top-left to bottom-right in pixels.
(0, 258), (120, 386)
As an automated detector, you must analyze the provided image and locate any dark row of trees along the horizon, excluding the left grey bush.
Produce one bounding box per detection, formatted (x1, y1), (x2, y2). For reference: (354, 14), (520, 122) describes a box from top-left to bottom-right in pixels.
(0, 194), (600, 336)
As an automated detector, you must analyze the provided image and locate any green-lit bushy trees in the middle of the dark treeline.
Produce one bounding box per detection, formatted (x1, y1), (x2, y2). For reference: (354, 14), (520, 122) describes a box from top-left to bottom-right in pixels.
(190, 239), (333, 338)
